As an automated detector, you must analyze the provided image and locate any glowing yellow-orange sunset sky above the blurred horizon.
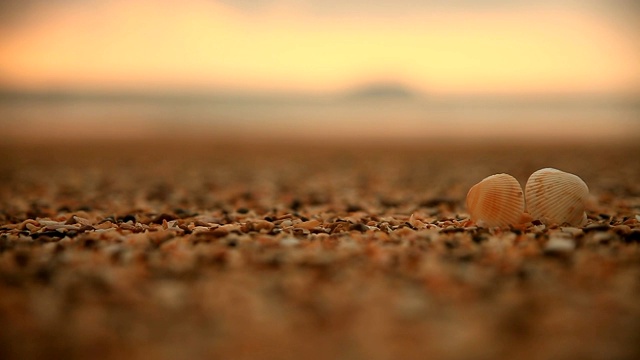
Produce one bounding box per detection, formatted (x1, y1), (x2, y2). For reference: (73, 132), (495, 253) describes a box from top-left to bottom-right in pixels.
(0, 0), (640, 94)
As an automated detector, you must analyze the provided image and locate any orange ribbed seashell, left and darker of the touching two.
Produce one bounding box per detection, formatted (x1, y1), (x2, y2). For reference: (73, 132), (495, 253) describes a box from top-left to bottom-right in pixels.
(467, 174), (524, 227)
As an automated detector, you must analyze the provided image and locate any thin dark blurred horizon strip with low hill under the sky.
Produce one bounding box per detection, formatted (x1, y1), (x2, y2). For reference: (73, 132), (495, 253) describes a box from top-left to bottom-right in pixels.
(0, 82), (640, 106)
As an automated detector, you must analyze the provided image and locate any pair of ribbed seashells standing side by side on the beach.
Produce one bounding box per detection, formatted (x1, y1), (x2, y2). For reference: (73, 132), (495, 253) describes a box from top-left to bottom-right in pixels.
(467, 168), (589, 227)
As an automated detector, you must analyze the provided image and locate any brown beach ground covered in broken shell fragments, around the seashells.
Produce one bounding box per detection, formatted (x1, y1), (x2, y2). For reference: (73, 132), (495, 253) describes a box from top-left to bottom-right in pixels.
(0, 139), (640, 359)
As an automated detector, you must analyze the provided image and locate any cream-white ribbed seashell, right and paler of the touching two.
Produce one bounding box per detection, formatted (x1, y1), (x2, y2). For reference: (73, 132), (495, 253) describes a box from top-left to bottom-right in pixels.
(525, 168), (589, 226)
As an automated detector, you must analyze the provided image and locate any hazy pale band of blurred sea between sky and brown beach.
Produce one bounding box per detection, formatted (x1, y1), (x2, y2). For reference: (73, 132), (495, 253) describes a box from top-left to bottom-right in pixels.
(0, 89), (640, 143)
